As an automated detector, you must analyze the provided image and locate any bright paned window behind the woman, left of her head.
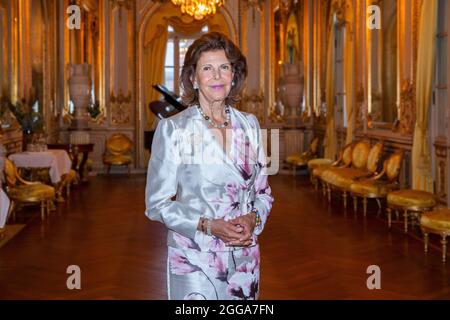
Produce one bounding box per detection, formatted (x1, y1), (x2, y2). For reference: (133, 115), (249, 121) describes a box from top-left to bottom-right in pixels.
(164, 26), (208, 95)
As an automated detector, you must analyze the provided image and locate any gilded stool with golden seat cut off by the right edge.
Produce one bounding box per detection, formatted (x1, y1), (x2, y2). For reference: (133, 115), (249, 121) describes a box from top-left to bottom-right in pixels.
(420, 208), (450, 263)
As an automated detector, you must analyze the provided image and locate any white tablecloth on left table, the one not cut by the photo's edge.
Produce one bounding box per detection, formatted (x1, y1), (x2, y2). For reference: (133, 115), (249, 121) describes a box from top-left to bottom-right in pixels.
(8, 149), (72, 183)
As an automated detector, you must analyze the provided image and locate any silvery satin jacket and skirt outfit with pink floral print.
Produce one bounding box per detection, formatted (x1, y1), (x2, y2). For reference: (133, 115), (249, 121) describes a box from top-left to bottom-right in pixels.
(145, 107), (273, 300)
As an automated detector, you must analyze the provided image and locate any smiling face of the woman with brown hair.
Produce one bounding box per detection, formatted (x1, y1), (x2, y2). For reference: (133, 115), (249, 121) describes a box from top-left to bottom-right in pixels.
(194, 50), (233, 104)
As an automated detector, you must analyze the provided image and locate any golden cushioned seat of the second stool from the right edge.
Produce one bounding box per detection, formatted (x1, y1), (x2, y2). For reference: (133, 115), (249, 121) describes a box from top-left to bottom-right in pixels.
(387, 189), (436, 208)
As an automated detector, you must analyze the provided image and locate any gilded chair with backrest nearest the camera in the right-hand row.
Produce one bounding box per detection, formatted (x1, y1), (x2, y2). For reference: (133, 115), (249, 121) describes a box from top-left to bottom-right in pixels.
(350, 150), (403, 216)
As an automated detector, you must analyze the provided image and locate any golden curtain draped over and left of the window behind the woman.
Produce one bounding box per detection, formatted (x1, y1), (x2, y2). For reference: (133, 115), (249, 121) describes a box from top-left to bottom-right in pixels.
(136, 2), (237, 168)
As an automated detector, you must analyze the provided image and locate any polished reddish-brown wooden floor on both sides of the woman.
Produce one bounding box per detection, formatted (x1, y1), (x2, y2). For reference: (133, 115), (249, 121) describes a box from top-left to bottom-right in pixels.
(0, 175), (450, 299)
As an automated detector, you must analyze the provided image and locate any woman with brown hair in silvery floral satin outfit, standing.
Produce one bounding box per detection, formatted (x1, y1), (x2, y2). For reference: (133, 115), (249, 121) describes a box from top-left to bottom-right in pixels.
(146, 32), (273, 300)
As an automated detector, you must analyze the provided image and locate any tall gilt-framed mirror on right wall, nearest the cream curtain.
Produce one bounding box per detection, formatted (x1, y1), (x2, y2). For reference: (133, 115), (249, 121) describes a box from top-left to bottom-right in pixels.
(367, 0), (400, 129)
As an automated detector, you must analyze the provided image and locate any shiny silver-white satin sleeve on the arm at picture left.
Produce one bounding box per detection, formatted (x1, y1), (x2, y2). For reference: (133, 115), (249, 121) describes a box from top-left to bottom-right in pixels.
(145, 119), (202, 239)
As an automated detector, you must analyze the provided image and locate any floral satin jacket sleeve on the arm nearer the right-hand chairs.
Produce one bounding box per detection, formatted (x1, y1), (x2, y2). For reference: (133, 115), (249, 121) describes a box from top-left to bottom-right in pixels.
(251, 115), (274, 235)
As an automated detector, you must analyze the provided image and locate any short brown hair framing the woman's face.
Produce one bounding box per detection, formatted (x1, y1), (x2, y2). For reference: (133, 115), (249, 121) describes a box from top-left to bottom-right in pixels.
(180, 32), (247, 106)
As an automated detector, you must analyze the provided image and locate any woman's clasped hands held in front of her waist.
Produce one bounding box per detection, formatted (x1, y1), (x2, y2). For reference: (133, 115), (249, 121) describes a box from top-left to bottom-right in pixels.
(211, 212), (256, 247)
